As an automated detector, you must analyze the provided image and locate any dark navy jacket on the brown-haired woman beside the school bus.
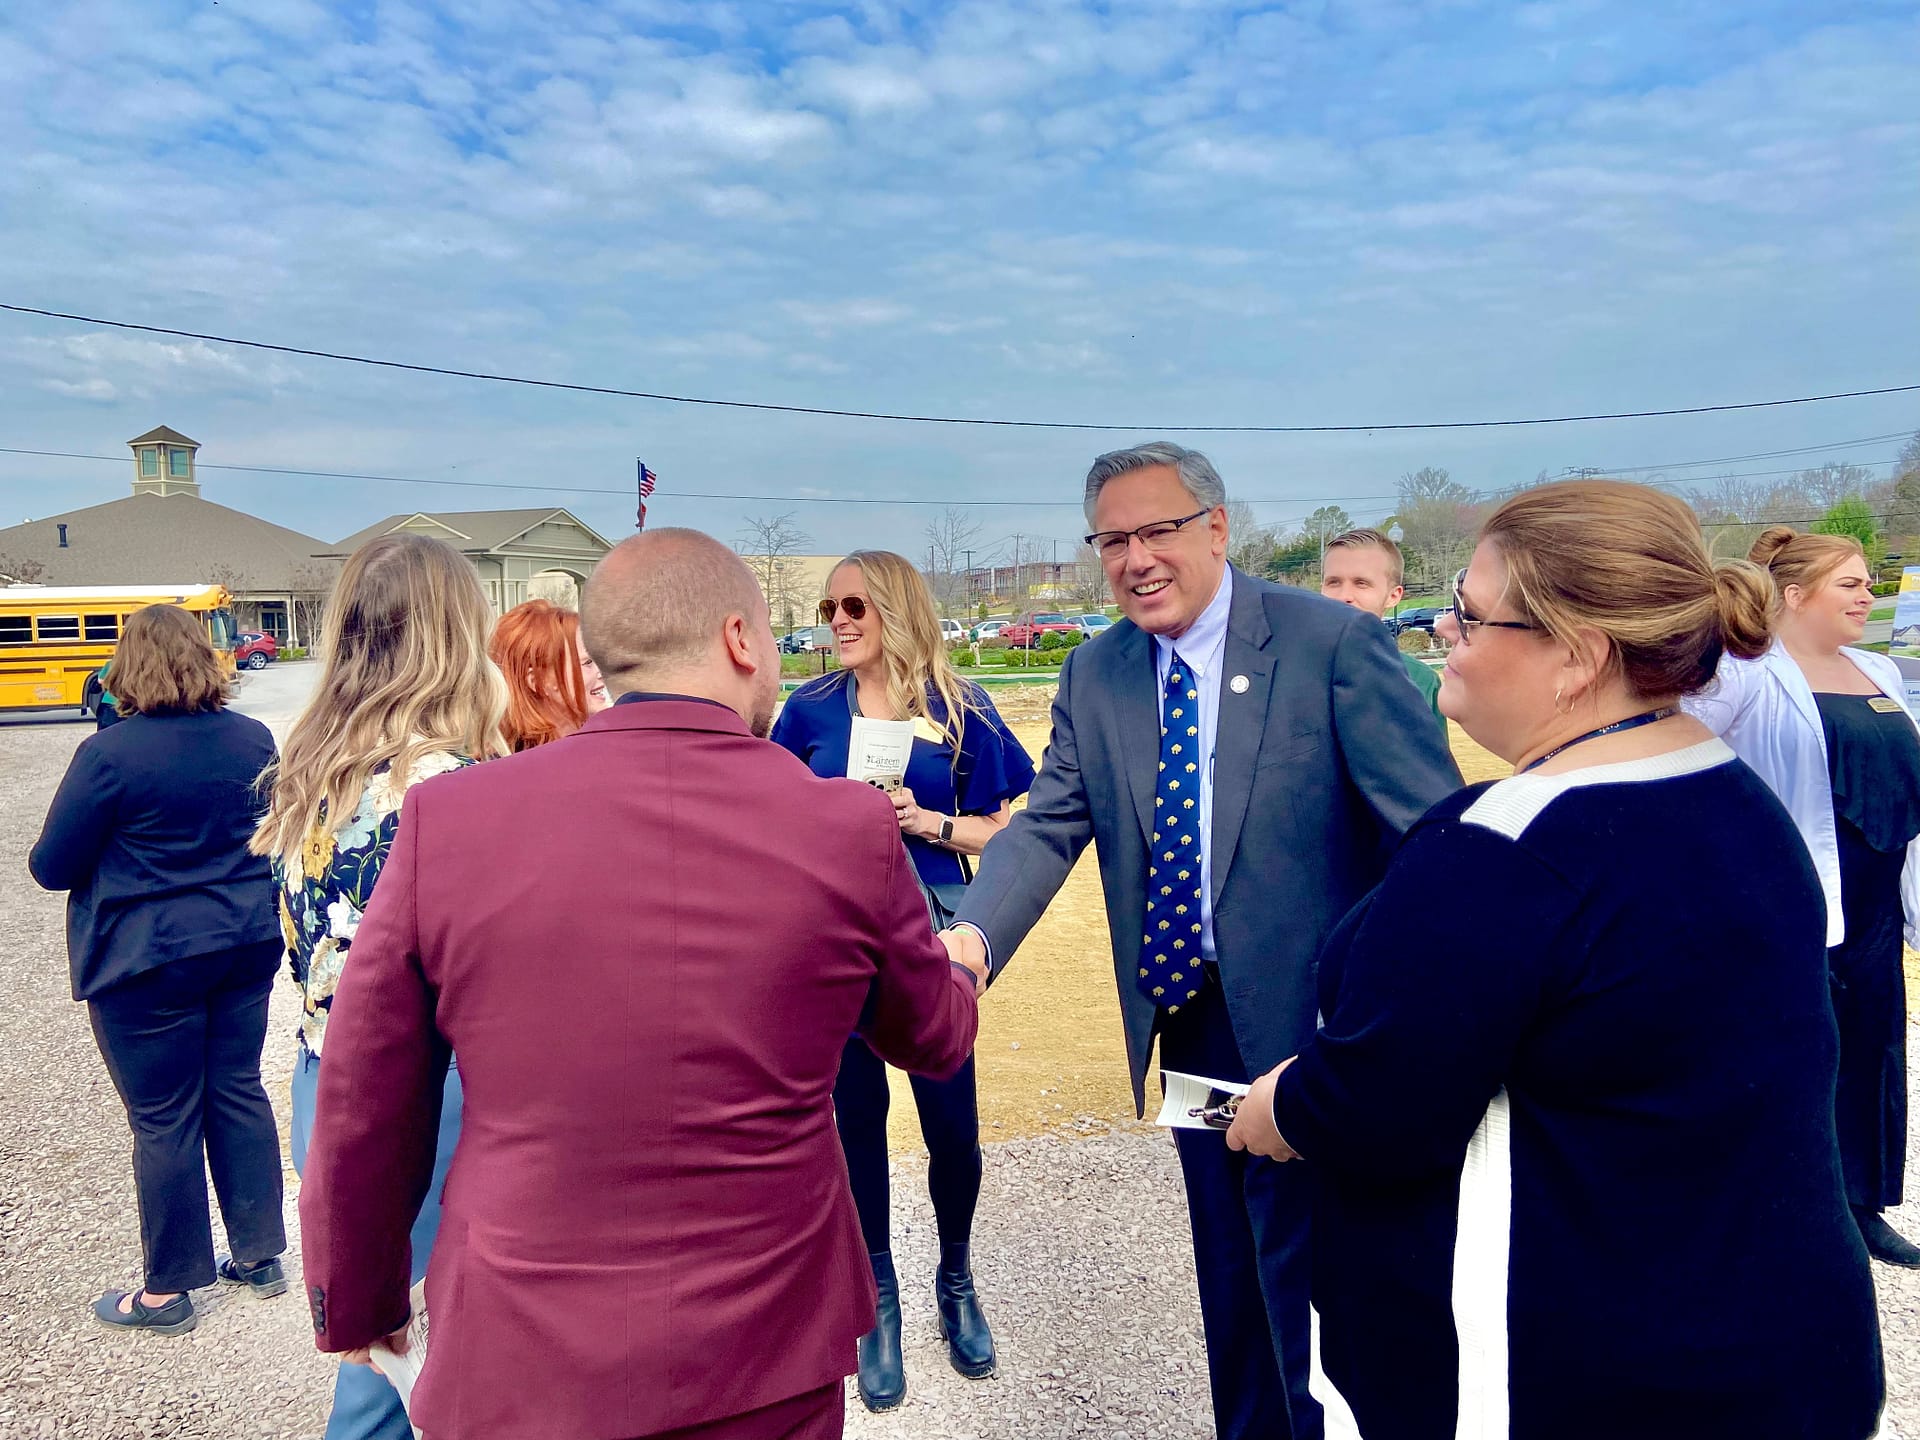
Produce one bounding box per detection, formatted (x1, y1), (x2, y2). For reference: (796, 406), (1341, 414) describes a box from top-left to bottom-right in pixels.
(27, 710), (280, 1000)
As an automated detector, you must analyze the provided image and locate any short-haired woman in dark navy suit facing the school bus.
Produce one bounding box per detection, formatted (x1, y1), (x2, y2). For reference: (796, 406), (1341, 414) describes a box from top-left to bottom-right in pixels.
(29, 605), (286, 1334)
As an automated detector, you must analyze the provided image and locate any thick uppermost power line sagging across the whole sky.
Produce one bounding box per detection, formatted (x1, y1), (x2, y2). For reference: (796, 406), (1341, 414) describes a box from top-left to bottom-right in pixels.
(0, 301), (1920, 436)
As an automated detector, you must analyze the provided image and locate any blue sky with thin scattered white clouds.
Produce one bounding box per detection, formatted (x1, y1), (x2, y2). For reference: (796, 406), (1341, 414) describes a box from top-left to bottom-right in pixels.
(0, 0), (1920, 553)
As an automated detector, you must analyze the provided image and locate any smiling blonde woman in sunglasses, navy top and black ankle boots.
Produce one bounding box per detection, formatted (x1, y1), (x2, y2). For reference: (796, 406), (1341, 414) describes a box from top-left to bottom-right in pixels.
(774, 551), (1033, 1411)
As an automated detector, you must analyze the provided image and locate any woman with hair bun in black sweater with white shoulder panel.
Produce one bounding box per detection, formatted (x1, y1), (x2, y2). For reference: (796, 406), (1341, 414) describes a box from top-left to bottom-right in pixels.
(1229, 482), (1884, 1440)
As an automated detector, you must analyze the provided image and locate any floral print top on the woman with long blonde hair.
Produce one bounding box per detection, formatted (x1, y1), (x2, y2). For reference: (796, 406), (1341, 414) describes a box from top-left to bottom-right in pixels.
(273, 751), (472, 1054)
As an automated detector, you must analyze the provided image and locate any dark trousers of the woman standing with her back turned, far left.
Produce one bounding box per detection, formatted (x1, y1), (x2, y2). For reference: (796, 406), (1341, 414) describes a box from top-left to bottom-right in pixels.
(86, 939), (286, 1294)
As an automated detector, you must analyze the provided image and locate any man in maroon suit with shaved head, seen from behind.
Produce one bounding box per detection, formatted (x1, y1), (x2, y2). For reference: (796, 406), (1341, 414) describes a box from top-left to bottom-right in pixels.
(300, 530), (977, 1440)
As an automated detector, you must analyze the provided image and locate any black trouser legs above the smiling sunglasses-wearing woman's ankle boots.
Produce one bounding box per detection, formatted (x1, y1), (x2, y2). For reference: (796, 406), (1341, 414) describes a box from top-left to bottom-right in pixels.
(833, 1035), (981, 1252)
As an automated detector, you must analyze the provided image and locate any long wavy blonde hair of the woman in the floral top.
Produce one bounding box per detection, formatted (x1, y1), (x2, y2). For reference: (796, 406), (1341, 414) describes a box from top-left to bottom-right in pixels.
(250, 534), (507, 860)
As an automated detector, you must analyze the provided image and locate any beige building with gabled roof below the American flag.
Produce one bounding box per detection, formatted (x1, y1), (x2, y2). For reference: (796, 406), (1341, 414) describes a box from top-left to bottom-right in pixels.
(326, 507), (612, 614)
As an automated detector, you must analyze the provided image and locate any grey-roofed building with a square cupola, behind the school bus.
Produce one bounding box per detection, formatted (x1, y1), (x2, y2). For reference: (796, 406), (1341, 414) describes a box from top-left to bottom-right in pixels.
(0, 426), (340, 645)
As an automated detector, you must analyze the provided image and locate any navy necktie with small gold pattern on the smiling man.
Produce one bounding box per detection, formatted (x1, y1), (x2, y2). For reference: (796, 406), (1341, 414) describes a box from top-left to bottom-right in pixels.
(1139, 651), (1202, 1016)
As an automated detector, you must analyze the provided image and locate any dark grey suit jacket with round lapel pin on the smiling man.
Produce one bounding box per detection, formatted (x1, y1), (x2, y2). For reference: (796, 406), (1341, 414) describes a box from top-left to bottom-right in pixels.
(954, 570), (1459, 1114)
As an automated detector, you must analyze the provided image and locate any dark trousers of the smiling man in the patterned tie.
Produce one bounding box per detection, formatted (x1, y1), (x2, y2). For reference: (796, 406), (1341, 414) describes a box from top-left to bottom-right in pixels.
(1160, 977), (1325, 1440)
